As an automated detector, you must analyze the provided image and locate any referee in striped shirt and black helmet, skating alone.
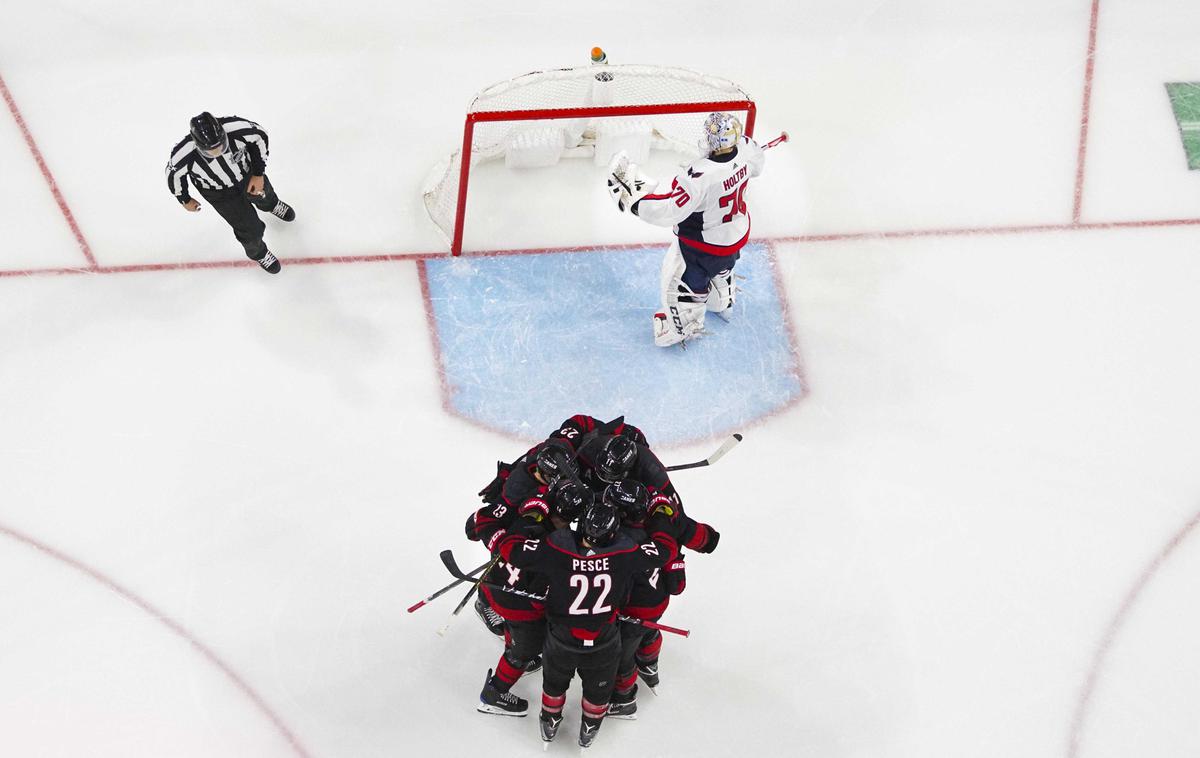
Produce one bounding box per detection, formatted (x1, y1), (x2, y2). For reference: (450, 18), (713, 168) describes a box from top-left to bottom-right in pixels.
(167, 112), (296, 273)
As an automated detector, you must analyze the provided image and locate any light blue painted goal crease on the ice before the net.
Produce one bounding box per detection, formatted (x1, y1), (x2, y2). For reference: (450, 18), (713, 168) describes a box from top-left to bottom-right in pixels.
(425, 243), (804, 445)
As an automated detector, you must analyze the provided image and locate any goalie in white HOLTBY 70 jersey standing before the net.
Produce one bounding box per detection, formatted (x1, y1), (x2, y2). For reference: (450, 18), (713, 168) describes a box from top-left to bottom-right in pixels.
(607, 113), (768, 348)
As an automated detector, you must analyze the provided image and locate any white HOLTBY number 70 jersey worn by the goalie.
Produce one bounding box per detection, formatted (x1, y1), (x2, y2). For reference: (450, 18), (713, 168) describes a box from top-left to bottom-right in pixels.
(630, 137), (766, 255)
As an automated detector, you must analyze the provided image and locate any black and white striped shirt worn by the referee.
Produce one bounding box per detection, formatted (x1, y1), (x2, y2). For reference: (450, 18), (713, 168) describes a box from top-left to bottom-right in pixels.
(167, 116), (268, 203)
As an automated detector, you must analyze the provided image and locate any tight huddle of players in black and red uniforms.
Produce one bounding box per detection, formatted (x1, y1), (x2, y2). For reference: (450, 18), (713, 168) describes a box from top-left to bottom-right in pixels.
(466, 415), (720, 747)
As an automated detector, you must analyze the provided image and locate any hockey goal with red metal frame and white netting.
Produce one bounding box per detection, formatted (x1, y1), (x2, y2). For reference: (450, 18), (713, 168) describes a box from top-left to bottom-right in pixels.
(422, 64), (755, 255)
